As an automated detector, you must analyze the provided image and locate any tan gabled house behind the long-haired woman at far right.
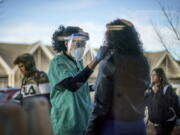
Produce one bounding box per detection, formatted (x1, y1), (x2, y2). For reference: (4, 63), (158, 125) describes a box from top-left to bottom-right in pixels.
(89, 50), (180, 96)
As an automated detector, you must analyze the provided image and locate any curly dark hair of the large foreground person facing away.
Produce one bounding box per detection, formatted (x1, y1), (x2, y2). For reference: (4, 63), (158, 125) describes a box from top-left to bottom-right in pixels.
(106, 19), (143, 55)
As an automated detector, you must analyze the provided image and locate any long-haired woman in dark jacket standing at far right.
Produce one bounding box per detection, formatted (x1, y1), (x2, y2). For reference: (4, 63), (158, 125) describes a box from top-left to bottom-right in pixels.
(146, 67), (180, 135)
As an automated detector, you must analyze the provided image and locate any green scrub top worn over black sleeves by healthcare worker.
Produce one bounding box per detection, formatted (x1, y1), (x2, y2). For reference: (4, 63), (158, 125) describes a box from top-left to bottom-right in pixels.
(48, 53), (92, 135)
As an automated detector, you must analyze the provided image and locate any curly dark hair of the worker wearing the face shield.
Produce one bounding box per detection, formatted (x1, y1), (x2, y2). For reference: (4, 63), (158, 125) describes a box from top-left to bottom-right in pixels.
(52, 25), (82, 52)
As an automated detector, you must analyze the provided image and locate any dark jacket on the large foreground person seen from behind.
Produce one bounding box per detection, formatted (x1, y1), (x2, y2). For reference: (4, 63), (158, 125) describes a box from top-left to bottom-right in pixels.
(87, 55), (150, 135)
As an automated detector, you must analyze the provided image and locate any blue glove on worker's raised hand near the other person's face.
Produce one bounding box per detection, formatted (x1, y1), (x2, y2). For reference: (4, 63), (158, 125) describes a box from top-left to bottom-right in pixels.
(95, 46), (108, 62)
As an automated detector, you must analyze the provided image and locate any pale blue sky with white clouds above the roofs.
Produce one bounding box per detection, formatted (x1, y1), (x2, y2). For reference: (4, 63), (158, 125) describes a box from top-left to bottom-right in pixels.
(0, 0), (180, 58)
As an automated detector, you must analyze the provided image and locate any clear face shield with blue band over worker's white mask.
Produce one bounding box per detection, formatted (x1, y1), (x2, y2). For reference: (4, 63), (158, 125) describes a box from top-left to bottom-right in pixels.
(68, 32), (89, 61)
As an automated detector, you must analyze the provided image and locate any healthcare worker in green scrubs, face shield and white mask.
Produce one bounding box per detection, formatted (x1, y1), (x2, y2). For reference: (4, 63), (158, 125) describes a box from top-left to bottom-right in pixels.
(48, 26), (107, 135)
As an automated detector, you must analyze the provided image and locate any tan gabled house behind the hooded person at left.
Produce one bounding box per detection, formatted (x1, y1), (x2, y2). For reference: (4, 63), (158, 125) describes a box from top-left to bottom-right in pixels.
(0, 42), (93, 88)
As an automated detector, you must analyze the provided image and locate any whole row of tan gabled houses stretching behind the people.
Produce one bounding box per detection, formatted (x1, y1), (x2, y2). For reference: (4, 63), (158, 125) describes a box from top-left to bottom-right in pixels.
(0, 42), (180, 94)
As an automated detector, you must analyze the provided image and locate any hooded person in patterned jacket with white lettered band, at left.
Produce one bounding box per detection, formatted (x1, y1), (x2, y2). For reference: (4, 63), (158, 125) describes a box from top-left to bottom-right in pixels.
(14, 53), (51, 103)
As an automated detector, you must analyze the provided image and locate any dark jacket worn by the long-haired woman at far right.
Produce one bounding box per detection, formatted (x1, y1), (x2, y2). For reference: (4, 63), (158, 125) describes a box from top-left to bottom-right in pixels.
(145, 85), (180, 124)
